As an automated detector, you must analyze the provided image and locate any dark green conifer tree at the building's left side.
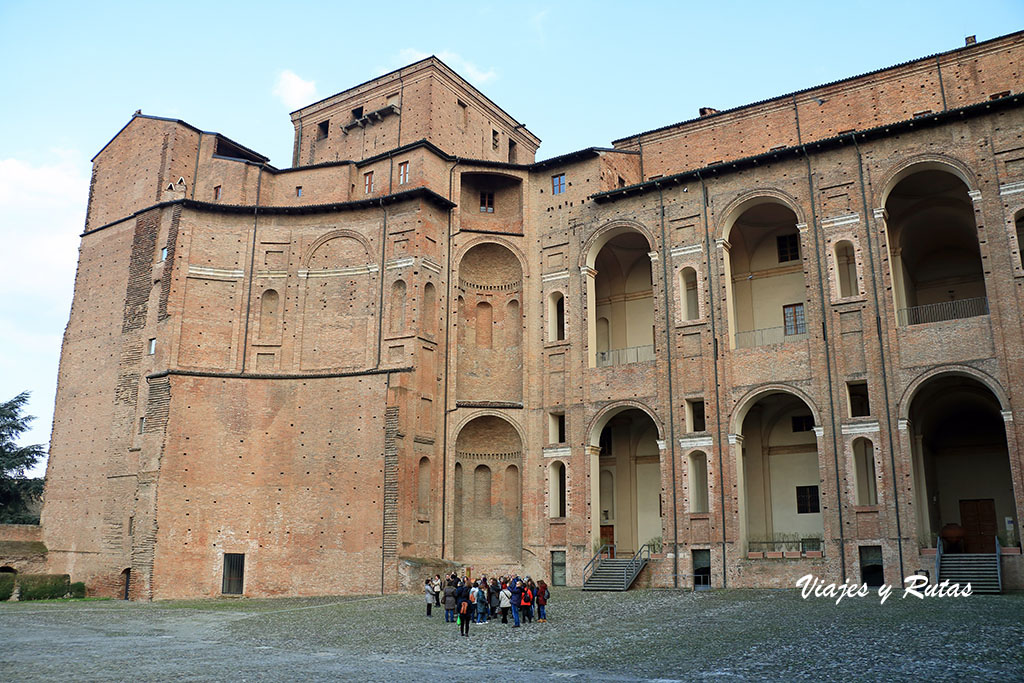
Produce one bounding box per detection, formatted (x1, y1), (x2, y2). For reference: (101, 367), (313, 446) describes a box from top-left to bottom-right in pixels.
(0, 391), (46, 524)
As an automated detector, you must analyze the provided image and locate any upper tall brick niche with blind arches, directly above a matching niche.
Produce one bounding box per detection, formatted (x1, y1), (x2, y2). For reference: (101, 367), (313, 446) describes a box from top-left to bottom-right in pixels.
(456, 242), (522, 402)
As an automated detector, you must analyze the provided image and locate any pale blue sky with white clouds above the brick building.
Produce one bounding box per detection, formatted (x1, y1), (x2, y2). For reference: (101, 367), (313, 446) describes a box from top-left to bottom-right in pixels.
(0, 0), (1024, 476)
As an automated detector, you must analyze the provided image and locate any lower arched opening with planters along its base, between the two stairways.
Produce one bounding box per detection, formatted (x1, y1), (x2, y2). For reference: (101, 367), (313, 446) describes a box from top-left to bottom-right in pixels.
(737, 392), (824, 552)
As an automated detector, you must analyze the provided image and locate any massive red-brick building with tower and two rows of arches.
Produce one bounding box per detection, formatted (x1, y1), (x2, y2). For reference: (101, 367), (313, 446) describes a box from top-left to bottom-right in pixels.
(28, 33), (1024, 598)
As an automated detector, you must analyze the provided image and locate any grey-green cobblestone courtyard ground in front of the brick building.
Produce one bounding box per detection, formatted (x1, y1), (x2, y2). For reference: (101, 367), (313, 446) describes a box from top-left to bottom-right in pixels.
(0, 589), (1024, 681)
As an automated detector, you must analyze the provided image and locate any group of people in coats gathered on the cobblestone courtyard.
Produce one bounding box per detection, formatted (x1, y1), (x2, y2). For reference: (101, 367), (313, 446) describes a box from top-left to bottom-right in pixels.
(423, 573), (551, 636)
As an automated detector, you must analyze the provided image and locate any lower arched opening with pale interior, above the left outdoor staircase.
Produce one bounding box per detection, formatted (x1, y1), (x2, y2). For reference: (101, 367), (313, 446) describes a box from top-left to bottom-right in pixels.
(590, 408), (662, 554)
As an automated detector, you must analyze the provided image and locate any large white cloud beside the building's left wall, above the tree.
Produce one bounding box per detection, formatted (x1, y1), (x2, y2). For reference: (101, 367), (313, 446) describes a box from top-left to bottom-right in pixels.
(0, 150), (89, 476)
